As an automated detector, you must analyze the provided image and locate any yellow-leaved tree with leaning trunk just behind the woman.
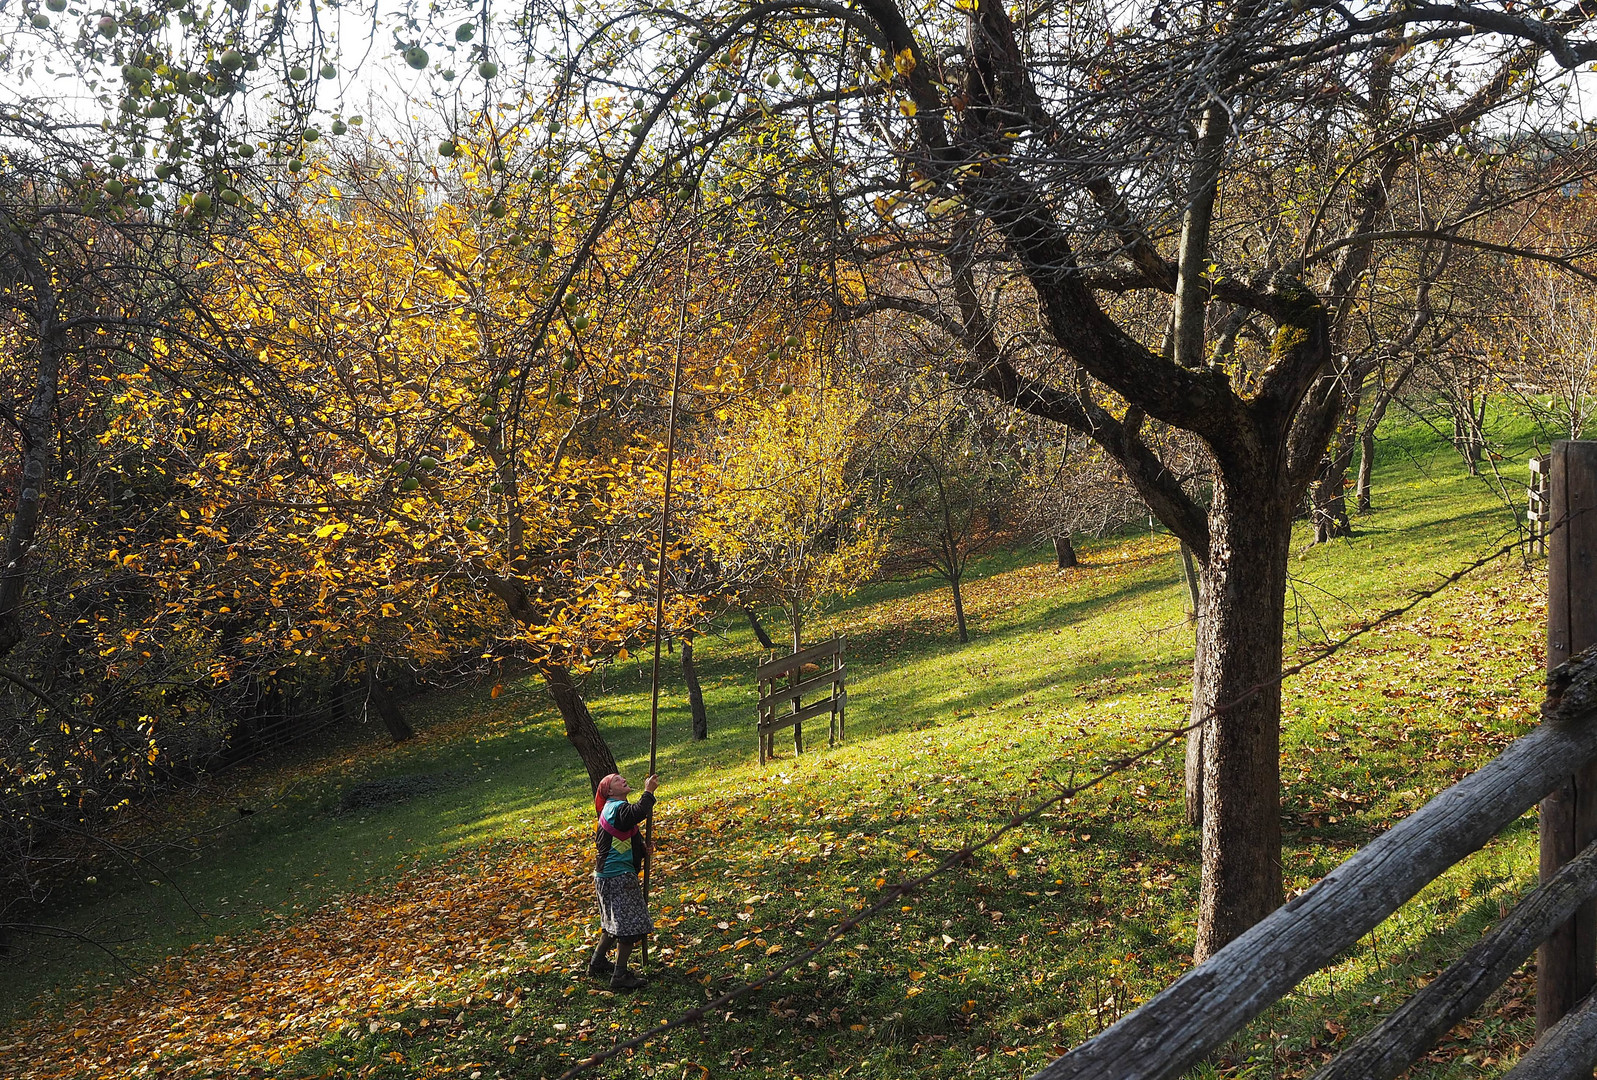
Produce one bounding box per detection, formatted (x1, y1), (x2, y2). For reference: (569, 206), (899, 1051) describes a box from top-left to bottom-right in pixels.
(191, 139), (714, 781)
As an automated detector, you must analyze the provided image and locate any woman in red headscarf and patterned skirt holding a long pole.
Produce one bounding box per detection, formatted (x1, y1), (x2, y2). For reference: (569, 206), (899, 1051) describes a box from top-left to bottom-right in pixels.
(588, 773), (660, 991)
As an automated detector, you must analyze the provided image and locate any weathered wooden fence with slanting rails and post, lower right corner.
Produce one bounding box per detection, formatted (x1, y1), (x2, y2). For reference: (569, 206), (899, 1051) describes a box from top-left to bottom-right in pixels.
(1033, 443), (1597, 1080)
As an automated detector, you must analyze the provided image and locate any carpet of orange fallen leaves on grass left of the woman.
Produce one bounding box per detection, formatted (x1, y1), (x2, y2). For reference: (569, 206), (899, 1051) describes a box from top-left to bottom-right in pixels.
(0, 839), (591, 1080)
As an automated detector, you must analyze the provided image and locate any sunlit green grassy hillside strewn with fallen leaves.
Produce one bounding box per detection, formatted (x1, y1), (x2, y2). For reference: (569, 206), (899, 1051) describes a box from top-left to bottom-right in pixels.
(0, 417), (1544, 1080)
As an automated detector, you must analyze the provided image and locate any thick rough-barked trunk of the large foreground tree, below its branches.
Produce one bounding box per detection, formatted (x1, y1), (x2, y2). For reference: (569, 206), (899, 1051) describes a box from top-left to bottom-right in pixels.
(1193, 476), (1292, 960)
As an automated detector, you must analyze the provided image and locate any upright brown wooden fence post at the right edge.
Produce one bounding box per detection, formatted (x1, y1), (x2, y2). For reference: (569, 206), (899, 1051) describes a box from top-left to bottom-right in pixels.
(1536, 441), (1597, 1037)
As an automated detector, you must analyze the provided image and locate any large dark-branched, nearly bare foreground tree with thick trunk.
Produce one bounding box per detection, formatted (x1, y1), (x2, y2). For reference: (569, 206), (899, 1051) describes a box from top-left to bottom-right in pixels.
(517, 0), (1597, 957)
